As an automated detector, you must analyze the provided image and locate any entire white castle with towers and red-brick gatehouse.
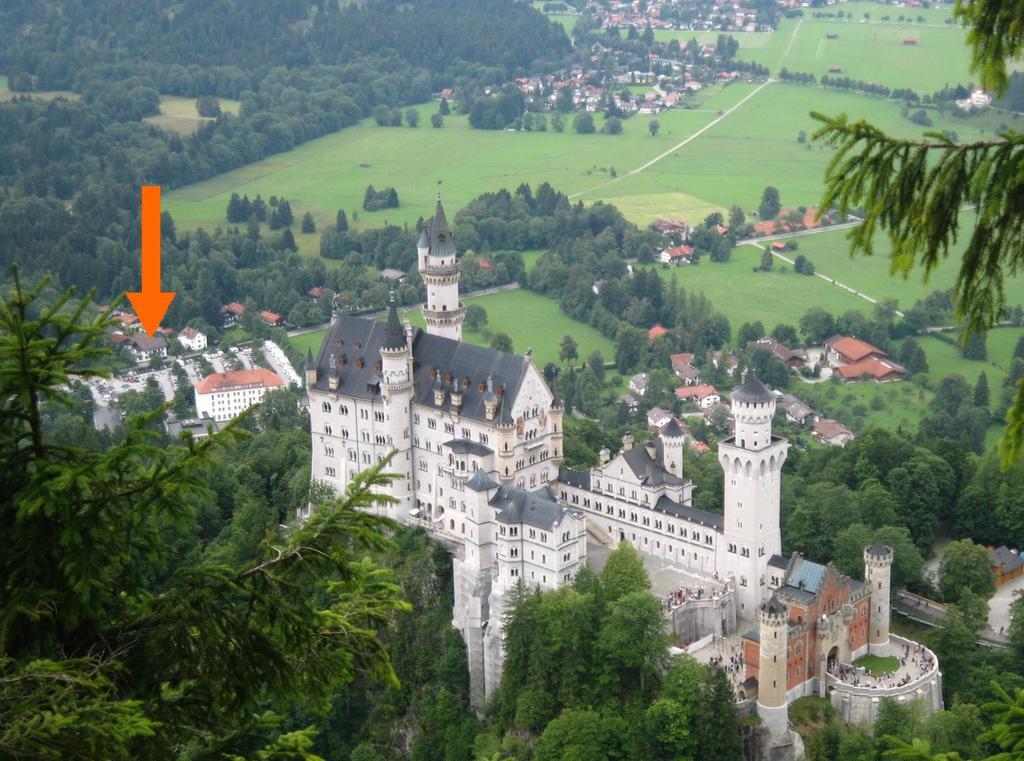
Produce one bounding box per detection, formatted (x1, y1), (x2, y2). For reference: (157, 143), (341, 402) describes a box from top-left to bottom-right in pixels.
(306, 200), (941, 737)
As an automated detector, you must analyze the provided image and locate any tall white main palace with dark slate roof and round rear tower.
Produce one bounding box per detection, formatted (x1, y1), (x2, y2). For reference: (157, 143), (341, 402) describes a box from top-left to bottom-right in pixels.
(306, 201), (586, 706)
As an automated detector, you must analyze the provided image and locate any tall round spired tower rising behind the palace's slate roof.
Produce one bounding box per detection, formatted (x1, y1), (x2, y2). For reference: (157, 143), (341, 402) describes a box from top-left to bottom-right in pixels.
(416, 198), (466, 341)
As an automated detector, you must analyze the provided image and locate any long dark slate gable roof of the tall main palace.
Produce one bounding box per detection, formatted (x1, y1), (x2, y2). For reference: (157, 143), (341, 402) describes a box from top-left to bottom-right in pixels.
(312, 316), (528, 422)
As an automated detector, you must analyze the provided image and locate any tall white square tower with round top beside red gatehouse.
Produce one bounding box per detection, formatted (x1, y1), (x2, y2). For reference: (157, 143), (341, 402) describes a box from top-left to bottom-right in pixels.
(718, 376), (790, 621)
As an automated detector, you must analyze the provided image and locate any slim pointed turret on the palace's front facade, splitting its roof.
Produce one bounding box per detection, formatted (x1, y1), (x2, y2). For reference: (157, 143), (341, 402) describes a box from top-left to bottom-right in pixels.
(381, 295), (415, 511)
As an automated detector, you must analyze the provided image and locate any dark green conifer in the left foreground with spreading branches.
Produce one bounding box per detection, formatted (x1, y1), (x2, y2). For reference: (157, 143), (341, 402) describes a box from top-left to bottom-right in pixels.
(0, 270), (409, 759)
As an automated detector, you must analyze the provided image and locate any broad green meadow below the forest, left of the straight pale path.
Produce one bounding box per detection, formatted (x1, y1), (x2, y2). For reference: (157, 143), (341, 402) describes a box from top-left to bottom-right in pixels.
(164, 94), (749, 235)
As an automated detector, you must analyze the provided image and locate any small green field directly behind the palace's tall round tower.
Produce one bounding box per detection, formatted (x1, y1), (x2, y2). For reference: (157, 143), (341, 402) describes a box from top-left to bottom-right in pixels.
(291, 290), (615, 369)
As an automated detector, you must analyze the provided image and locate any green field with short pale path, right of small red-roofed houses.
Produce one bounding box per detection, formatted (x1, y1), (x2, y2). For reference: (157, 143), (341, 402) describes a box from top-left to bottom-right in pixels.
(638, 246), (870, 334)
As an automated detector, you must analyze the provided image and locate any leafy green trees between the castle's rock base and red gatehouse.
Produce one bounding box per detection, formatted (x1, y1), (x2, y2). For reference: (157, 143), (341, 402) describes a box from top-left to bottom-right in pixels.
(476, 542), (743, 761)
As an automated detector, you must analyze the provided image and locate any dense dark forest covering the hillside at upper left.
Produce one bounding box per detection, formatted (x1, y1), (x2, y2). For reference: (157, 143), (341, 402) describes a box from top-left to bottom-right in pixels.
(0, 0), (568, 298)
